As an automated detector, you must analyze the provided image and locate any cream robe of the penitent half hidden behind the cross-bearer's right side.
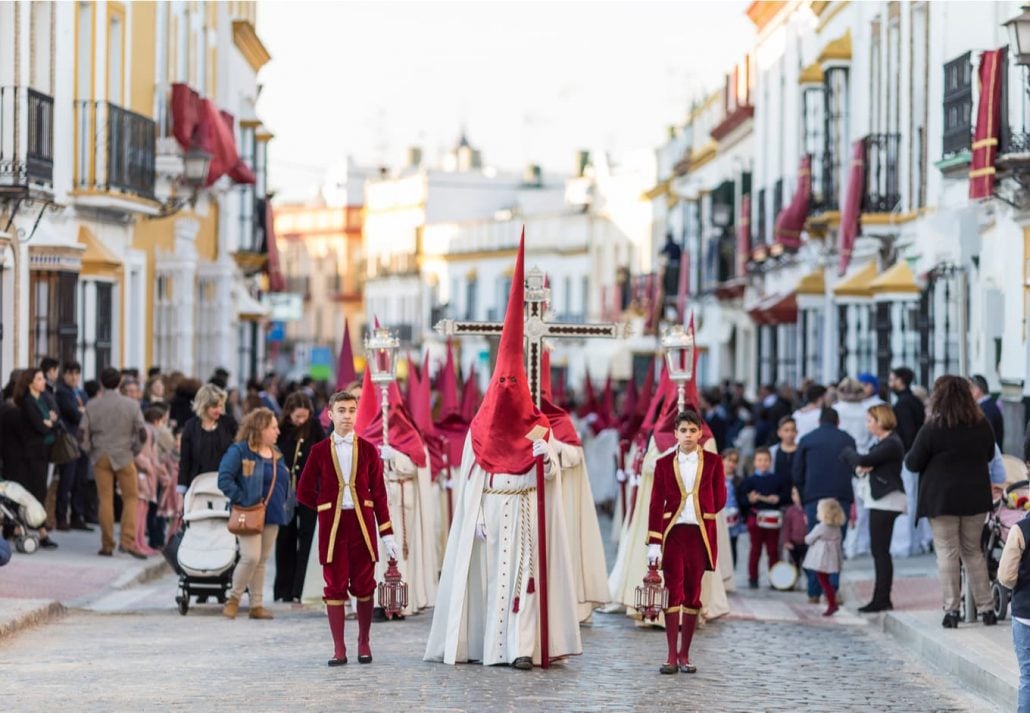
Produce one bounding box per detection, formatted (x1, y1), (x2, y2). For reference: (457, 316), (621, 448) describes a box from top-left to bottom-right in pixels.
(551, 439), (608, 621)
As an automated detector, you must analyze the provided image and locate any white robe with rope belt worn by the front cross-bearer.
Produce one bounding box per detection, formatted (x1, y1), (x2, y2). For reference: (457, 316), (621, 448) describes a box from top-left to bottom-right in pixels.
(424, 435), (583, 666)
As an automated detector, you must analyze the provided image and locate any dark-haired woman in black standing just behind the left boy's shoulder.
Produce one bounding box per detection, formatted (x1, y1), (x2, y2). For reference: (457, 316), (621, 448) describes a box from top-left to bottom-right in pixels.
(273, 392), (325, 602)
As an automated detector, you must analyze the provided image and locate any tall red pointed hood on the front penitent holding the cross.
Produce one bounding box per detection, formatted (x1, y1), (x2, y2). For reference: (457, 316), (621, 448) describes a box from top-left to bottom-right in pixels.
(470, 229), (549, 473)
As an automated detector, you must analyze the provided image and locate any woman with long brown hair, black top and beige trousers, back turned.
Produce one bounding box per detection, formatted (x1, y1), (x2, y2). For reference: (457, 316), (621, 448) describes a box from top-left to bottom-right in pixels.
(904, 376), (997, 629)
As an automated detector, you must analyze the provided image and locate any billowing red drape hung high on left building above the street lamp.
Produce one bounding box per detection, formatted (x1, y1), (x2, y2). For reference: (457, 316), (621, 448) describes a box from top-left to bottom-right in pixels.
(172, 83), (256, 186)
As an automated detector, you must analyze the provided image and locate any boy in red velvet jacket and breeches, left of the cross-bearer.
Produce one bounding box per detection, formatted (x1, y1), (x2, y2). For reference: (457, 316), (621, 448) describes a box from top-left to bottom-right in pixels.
(297, 392), (398, 666)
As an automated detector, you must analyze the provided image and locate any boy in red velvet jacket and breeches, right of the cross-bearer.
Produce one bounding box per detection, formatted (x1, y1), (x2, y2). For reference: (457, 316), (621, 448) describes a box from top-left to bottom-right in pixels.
(648, 411), (726, 674)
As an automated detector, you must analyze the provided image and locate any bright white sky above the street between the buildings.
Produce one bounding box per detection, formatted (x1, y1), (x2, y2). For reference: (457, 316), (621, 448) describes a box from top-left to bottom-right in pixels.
(258, 0), (753, 200)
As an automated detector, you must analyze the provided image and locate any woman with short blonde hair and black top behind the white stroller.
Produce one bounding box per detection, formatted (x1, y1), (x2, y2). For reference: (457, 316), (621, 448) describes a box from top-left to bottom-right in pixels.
(178, 383), (238, 493)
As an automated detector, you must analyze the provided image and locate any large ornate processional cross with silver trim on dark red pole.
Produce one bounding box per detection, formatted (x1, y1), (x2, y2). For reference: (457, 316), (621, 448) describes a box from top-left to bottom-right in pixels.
(435, 261), (628, 669)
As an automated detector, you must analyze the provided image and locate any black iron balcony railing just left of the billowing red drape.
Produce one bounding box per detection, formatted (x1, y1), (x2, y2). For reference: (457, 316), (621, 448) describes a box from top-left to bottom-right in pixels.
(75, 101), (157, 200)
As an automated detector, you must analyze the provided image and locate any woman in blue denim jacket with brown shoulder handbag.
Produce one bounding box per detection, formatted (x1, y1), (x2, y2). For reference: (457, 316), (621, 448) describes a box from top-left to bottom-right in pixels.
(218, 408), (289, 619)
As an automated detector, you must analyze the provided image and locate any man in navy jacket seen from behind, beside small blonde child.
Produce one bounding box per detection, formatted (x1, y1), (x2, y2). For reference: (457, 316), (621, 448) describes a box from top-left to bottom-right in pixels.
(794, 408), (855, 603)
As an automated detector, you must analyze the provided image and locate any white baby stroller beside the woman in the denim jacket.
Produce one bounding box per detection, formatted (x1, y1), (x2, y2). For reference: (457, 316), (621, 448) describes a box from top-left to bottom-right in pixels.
(175, 473), (238, 616)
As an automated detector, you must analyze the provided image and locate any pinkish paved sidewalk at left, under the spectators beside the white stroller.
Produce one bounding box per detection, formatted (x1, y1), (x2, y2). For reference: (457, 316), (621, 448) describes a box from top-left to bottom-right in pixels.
(0, 529), (169, 642)
